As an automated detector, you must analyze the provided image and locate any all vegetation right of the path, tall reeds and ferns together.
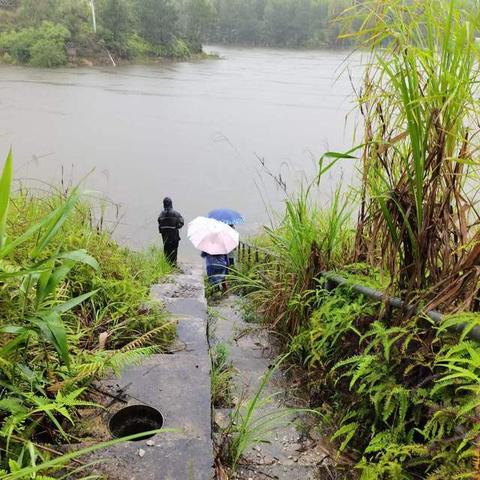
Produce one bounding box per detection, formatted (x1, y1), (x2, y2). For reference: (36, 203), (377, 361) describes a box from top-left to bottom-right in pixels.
(237, 0), (480, 480)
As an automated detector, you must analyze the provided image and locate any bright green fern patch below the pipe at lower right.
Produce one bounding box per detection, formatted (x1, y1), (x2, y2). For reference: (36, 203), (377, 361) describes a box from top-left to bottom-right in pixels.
(291, 288), (480, 480)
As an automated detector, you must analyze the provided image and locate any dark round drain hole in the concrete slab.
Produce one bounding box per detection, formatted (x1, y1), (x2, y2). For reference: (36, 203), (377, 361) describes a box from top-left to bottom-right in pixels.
(108, 405), (163, 441)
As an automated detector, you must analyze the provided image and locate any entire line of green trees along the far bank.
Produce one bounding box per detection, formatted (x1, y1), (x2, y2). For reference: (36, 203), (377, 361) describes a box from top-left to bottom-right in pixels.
(0, 0), (351, 67)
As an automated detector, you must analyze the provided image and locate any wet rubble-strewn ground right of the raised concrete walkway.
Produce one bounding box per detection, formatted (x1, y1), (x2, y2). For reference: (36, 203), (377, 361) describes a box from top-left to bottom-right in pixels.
(210, 296), (337, 480)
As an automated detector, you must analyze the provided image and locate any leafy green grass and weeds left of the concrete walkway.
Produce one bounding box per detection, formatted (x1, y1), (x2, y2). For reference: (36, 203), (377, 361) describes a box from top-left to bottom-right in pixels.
(0, 149), (175, 479)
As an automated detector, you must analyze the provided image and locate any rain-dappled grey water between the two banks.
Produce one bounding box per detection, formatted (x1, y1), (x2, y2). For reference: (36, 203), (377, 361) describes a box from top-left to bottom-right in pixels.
(0, 47), (361, 256)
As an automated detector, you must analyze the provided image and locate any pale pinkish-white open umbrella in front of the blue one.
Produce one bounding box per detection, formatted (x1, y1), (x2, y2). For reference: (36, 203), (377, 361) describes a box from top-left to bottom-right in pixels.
(187, 217), (240, 255)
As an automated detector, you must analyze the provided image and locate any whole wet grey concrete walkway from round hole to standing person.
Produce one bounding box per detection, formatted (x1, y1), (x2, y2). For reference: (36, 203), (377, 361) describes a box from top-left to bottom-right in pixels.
(86, 266), (213, 480)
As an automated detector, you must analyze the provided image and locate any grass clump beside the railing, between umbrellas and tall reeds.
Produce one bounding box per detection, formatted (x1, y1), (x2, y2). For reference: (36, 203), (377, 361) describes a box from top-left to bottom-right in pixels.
(231, 184), (355, 337)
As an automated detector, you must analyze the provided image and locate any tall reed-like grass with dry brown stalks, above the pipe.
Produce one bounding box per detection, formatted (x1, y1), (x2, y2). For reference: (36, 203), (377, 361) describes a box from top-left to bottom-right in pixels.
(349, 0), (480, 307)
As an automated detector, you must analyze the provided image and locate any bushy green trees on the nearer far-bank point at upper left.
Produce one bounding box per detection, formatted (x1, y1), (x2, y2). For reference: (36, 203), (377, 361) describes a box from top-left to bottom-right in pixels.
(0, 0), (201, 67)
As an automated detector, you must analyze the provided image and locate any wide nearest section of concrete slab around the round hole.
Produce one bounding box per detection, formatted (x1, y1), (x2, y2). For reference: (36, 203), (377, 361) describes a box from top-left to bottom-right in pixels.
(94, 353), (213, 480)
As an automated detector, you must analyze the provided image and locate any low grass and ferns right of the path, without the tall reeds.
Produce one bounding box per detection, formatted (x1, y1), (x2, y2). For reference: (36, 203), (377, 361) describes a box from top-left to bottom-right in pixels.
(238, 148), (480, 480)
